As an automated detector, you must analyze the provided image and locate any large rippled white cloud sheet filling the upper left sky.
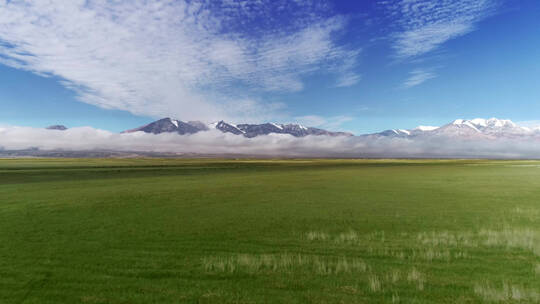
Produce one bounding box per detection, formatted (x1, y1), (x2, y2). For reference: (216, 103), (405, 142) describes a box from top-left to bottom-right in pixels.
(0, 0), (358, 120)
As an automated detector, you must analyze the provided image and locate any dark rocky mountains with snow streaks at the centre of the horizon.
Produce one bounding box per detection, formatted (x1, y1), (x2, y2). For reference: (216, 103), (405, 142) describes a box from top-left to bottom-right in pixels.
(125, 118), (353, 138)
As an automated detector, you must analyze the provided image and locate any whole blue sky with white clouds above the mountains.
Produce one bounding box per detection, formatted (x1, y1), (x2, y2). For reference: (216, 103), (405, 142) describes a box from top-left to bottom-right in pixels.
(0, 0), (540, 134)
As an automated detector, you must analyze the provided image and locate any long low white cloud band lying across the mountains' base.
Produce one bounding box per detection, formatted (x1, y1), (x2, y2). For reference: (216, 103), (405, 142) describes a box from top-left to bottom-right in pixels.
(0, 127), (540, 158)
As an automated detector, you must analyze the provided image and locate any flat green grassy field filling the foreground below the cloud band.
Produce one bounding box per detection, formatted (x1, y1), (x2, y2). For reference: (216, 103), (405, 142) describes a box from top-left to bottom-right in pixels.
(0, 159), (540, 303)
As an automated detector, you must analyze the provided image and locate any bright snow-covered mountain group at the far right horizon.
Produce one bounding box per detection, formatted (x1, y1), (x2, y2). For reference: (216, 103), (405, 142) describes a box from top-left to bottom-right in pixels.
(366, 118), (540, 138)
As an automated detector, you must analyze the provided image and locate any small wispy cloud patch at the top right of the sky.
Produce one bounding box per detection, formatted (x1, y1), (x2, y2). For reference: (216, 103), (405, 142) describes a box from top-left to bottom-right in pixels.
(380, 0), (498, 58)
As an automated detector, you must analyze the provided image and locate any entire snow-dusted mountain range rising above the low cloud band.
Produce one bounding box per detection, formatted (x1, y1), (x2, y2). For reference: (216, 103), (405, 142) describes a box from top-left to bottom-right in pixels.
(47, 118), (540, 139)
